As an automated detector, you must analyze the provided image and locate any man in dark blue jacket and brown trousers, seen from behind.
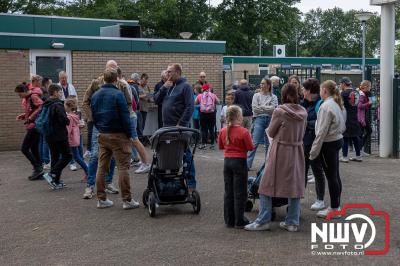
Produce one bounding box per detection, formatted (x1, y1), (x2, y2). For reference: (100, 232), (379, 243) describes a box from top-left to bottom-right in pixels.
(91, 68), (139, 209)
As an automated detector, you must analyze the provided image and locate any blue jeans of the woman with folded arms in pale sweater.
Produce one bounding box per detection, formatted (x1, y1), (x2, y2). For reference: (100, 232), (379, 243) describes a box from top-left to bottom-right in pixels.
(247, 116), (271, 169)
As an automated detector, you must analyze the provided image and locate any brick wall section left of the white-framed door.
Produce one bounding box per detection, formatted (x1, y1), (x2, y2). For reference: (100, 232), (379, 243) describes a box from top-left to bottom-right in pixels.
(0, 49), (29, 151)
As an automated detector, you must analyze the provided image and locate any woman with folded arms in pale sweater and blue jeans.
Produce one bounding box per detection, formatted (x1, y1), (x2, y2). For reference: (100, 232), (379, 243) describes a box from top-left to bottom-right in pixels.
(247, 78), (278, 169)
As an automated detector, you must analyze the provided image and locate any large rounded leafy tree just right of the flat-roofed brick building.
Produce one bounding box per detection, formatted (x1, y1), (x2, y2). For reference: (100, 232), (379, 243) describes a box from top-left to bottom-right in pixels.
(210, 0), (300, 55)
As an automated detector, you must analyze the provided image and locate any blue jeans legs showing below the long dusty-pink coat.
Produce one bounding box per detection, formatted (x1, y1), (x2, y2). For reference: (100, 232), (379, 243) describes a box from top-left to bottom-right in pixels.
(255, 194), (300, 225)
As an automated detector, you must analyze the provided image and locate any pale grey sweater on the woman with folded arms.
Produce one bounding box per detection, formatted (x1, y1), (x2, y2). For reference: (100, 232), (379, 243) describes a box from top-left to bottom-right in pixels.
(251, 92), (278, 117)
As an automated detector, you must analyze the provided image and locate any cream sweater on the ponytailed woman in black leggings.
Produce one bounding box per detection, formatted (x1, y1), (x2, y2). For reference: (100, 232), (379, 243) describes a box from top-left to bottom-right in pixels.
(310, 97), (346, 160)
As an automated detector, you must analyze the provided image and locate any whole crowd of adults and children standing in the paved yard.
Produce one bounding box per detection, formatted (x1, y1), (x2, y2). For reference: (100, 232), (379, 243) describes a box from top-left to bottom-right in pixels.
(15, 60), (372, 231)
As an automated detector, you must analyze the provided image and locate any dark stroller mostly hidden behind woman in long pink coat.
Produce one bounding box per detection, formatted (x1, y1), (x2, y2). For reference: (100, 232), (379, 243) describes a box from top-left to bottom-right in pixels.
(245, 163), (288, 221)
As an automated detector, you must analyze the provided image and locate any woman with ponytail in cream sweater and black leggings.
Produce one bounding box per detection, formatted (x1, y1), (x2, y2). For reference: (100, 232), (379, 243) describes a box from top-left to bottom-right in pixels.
(310, 80), (346, 218)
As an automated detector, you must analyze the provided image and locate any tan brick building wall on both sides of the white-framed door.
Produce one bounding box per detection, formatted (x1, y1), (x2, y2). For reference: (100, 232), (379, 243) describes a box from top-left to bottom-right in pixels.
(0, 49), (222, 151)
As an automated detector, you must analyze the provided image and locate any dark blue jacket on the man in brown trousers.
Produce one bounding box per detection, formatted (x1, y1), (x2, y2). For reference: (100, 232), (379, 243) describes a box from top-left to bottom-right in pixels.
(91, 84), (132, 138)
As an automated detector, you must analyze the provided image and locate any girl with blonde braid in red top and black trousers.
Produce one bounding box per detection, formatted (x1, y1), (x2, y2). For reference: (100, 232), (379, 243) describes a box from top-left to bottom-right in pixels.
(218, 105), (253, 229)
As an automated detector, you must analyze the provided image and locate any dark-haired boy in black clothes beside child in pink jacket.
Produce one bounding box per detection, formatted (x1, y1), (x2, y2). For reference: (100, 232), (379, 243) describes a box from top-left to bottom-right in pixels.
(43, 84), (72, 189)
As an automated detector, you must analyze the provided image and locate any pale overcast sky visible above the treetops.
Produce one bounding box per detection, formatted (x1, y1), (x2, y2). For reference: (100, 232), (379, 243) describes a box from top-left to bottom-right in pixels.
(211, 0), (381, 13)
